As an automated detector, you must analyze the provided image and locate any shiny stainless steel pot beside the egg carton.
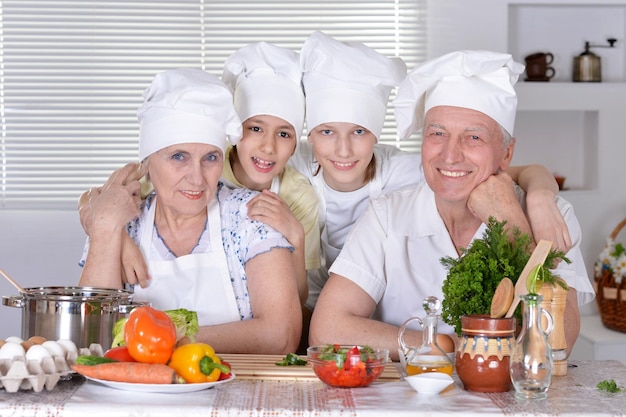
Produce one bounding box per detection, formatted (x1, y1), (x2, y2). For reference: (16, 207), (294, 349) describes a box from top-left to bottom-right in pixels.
(2, 287), (140, 350)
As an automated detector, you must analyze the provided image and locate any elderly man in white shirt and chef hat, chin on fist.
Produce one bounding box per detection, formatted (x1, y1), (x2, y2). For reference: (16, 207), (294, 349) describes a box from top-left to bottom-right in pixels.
(310, 51), (593, 360)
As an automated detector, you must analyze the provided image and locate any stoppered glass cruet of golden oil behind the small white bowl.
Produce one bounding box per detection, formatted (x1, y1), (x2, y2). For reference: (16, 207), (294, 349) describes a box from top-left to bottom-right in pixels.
(398, 296), (454, 375)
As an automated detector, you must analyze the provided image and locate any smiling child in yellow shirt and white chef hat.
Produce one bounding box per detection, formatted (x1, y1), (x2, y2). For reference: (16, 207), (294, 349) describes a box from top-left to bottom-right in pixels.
(222, 42), (320, 304)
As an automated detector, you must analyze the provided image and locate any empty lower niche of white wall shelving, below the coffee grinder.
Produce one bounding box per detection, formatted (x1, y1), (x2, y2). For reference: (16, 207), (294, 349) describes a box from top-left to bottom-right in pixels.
(513, 82), (626, 192)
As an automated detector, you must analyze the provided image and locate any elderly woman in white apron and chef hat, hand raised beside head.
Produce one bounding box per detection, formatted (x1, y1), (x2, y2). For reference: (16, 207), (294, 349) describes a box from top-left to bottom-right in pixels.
(79, 69), (302, 354)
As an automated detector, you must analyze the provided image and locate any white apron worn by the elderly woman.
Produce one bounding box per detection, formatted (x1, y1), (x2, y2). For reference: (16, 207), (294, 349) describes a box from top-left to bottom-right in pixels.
(133, 197), (240, 326)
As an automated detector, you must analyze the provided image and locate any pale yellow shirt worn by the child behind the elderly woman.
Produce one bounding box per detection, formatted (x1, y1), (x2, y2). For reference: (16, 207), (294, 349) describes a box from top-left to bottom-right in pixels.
(222, 147), (321, 270)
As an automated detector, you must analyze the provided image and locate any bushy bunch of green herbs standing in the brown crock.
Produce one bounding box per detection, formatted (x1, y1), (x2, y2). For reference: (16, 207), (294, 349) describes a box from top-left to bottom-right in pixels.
(441, 217), (569, 336)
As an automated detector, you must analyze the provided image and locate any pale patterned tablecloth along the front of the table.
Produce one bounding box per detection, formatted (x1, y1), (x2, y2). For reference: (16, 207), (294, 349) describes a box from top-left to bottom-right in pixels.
(0, 361), (626, 417)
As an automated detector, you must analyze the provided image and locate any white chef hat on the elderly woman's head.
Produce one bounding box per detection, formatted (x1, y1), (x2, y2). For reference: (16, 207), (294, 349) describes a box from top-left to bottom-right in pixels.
(137, 68), (241, 160)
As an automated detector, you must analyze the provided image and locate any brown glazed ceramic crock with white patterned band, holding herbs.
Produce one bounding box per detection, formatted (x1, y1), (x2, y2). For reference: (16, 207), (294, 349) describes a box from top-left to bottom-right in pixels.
(455, 315), (515, 392)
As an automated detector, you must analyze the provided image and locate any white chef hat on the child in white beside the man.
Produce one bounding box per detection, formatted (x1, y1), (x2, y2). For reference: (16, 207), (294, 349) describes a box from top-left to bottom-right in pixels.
(300, 32), (406, 138)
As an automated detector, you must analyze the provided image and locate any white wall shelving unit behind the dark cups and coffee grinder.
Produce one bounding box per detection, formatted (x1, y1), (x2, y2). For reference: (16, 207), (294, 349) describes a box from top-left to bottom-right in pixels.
(506, 0), (626, 193)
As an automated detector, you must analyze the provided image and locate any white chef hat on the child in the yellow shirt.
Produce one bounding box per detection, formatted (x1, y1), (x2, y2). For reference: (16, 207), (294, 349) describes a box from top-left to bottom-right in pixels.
(222, 42), (304, 139)
